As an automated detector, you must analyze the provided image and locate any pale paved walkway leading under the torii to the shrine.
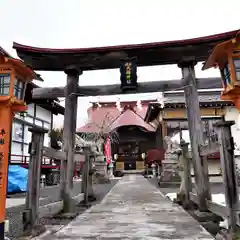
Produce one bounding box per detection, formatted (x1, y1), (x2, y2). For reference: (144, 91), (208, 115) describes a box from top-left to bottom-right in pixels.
(38, 175), (214, 240)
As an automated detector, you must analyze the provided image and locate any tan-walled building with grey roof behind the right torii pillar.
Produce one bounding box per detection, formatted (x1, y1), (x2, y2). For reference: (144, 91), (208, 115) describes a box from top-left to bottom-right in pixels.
(144, 89), (240, 175)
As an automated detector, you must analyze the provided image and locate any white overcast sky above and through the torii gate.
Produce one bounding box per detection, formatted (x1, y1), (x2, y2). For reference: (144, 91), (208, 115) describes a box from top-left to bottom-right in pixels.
(0, 0), (240, 126)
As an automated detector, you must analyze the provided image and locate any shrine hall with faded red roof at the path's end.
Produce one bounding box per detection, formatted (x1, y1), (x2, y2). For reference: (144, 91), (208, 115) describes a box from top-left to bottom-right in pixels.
(77, 101), (157, 171)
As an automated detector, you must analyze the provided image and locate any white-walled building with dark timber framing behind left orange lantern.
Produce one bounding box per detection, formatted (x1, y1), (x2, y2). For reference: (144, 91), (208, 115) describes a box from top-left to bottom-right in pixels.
(10, 83), (64, 164)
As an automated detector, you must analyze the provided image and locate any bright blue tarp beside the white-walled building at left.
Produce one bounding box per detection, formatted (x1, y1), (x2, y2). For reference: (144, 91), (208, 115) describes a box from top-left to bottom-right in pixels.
(8, 165), (28, 193)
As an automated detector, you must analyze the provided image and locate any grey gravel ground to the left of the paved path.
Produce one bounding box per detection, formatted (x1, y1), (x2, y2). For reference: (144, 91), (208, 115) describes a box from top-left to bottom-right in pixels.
(7, 179), (118, 240)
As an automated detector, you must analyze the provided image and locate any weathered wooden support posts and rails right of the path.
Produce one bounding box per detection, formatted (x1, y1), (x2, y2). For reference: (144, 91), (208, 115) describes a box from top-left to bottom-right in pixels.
(181, 118), (240, 232)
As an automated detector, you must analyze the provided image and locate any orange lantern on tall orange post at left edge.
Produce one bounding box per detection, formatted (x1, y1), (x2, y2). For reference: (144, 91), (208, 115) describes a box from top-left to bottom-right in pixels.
(0, 55), (37, 236)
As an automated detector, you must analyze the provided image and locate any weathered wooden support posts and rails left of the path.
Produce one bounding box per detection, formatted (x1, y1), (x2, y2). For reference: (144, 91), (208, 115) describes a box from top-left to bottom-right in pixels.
(23, 127), (94, 234)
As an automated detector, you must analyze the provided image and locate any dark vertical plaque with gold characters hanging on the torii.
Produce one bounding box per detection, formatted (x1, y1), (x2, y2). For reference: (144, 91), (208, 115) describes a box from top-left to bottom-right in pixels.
(120, 58), (137, 90)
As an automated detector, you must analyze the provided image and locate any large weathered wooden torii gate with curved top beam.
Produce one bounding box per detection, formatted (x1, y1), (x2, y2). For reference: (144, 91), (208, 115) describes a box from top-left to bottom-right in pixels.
(13, 30), (240, 211)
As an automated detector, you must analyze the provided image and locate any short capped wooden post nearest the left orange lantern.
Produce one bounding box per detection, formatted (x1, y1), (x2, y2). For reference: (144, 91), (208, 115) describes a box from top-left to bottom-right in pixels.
(23, 127), (48, 230)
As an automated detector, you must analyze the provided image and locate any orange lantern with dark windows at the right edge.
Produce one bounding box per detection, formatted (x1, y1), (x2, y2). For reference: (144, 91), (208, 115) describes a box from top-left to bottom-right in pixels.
(202, 32), (240, 109)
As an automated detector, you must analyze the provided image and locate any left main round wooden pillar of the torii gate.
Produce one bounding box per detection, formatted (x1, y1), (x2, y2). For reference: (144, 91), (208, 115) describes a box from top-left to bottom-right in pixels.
(61, 66), (80, 212)
